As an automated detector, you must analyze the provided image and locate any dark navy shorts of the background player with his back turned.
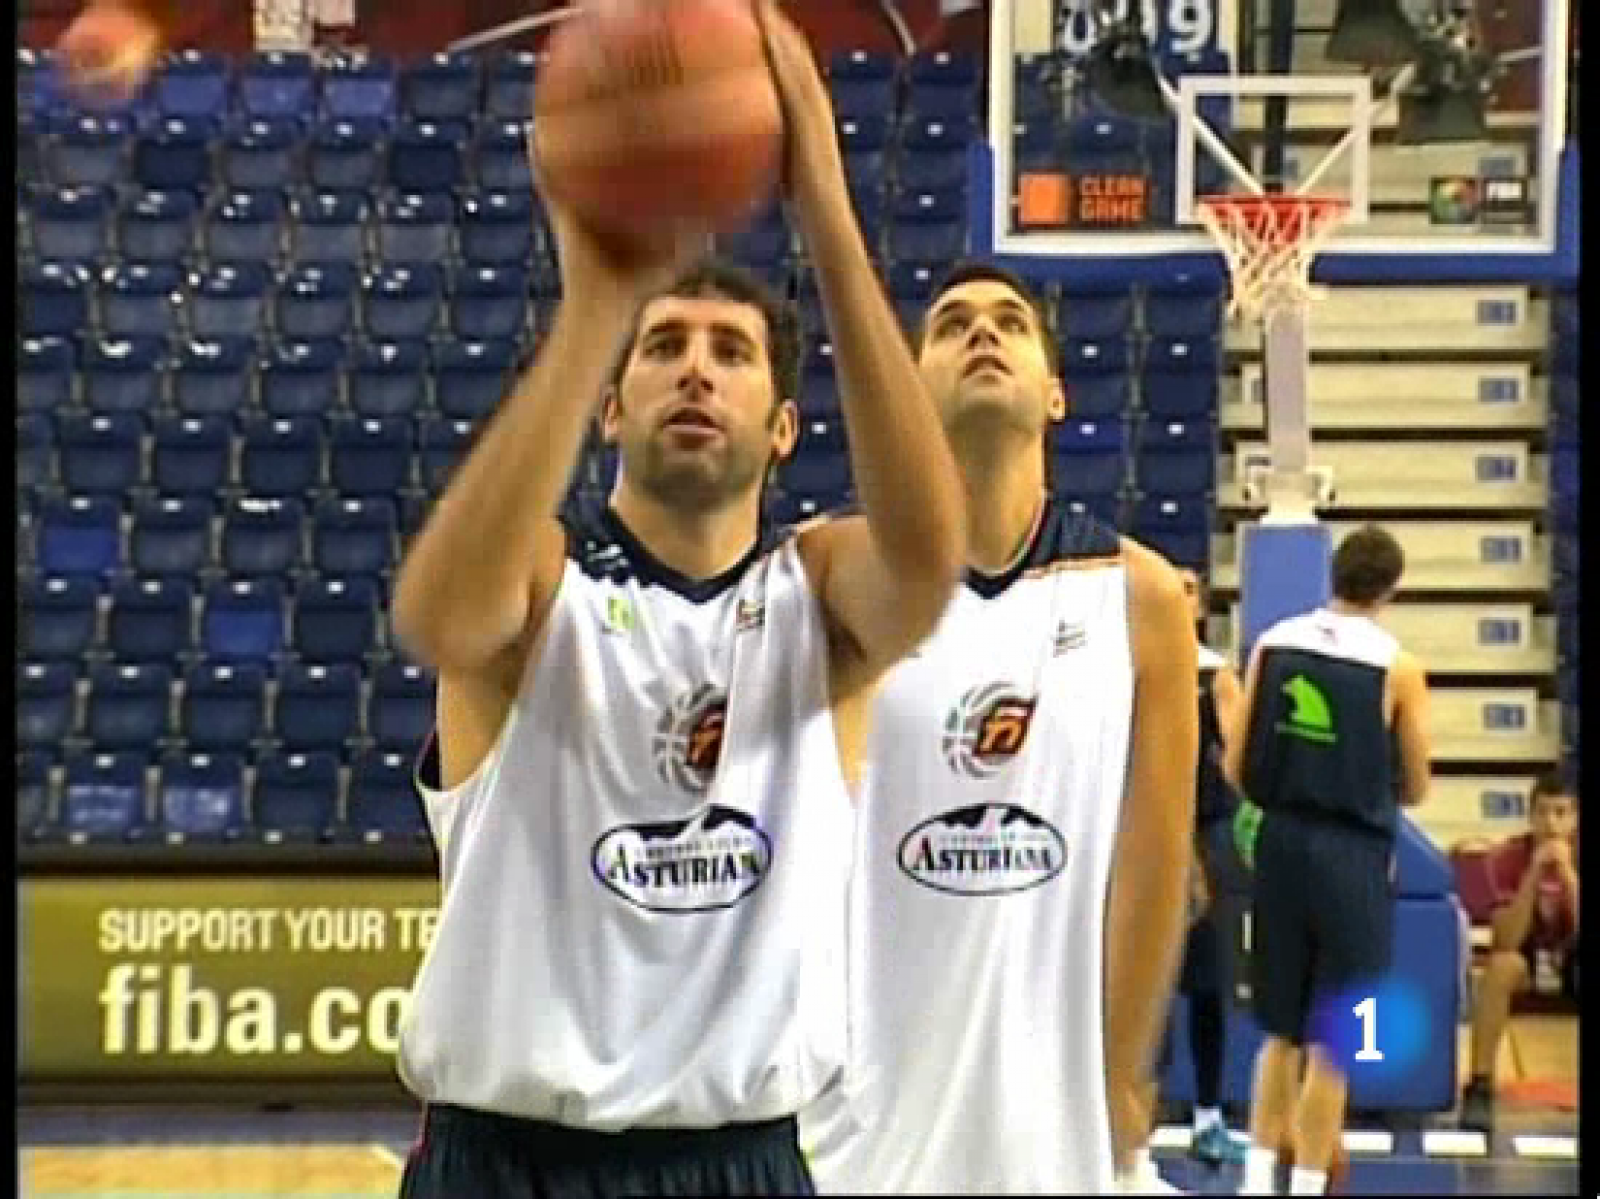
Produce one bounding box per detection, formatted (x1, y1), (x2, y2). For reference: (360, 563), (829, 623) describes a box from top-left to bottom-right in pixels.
(1250, 812), (1395, 1045)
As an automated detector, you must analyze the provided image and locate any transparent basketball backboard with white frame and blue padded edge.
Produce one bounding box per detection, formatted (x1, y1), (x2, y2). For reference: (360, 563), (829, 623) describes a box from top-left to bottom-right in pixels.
(973, 0), (1578, 282)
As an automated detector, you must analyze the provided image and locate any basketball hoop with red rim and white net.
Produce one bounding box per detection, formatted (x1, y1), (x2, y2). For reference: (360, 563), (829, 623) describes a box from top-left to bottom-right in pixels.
(1195, 194), (1350, 319)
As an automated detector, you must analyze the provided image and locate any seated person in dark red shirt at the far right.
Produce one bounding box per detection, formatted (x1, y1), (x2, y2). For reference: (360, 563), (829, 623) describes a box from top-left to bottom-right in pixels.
(1461, 773), (1579, 1132)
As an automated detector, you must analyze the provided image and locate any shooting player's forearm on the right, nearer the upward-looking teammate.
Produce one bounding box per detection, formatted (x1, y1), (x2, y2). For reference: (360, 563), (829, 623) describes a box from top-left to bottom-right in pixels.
(802, 197), (966, 623)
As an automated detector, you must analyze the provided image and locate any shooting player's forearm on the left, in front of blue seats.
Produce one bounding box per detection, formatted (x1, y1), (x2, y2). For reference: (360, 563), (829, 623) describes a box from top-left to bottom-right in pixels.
(394, 299), (630, 671)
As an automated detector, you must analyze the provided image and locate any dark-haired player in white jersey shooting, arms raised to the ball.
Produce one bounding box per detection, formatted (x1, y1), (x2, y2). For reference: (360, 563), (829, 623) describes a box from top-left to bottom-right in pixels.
(394, 5), (965, 1199)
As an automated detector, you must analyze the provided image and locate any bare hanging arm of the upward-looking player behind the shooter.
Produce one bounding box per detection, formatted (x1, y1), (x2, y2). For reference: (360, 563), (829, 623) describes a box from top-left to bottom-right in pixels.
(1106, 541), (1200, 1159)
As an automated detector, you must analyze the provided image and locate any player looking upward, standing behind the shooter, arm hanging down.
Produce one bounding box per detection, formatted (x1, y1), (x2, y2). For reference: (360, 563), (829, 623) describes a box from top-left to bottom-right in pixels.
(802, 263), (1198, 1194)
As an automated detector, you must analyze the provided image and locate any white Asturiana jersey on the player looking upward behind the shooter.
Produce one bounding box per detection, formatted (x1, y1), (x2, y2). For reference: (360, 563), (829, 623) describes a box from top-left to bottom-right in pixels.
(802, 503), (1133, 1194)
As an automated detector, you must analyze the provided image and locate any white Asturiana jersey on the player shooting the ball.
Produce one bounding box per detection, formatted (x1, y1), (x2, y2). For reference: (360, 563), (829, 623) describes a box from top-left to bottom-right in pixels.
(400, 512), (854, 1130)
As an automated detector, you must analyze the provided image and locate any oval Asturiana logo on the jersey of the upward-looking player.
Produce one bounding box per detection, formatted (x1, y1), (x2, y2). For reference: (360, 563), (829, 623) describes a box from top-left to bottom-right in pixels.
(899, 804), (1067, 895)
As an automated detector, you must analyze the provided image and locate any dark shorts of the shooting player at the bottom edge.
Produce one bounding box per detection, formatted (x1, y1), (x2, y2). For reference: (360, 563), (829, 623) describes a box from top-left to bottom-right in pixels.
(400, 1105), (816, 1199)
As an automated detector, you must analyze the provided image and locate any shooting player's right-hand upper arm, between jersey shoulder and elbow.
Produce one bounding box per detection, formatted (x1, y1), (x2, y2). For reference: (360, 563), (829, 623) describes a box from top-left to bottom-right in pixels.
(795, 515), (960, 679)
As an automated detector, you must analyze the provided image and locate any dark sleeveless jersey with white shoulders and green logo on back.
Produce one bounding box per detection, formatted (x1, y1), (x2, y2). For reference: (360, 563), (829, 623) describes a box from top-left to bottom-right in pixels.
(1243, 608), (1400, 836)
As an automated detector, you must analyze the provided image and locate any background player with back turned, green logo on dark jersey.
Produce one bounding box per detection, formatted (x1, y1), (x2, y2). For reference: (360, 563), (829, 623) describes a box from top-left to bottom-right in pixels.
(1226, 525), (1430, 1194)
